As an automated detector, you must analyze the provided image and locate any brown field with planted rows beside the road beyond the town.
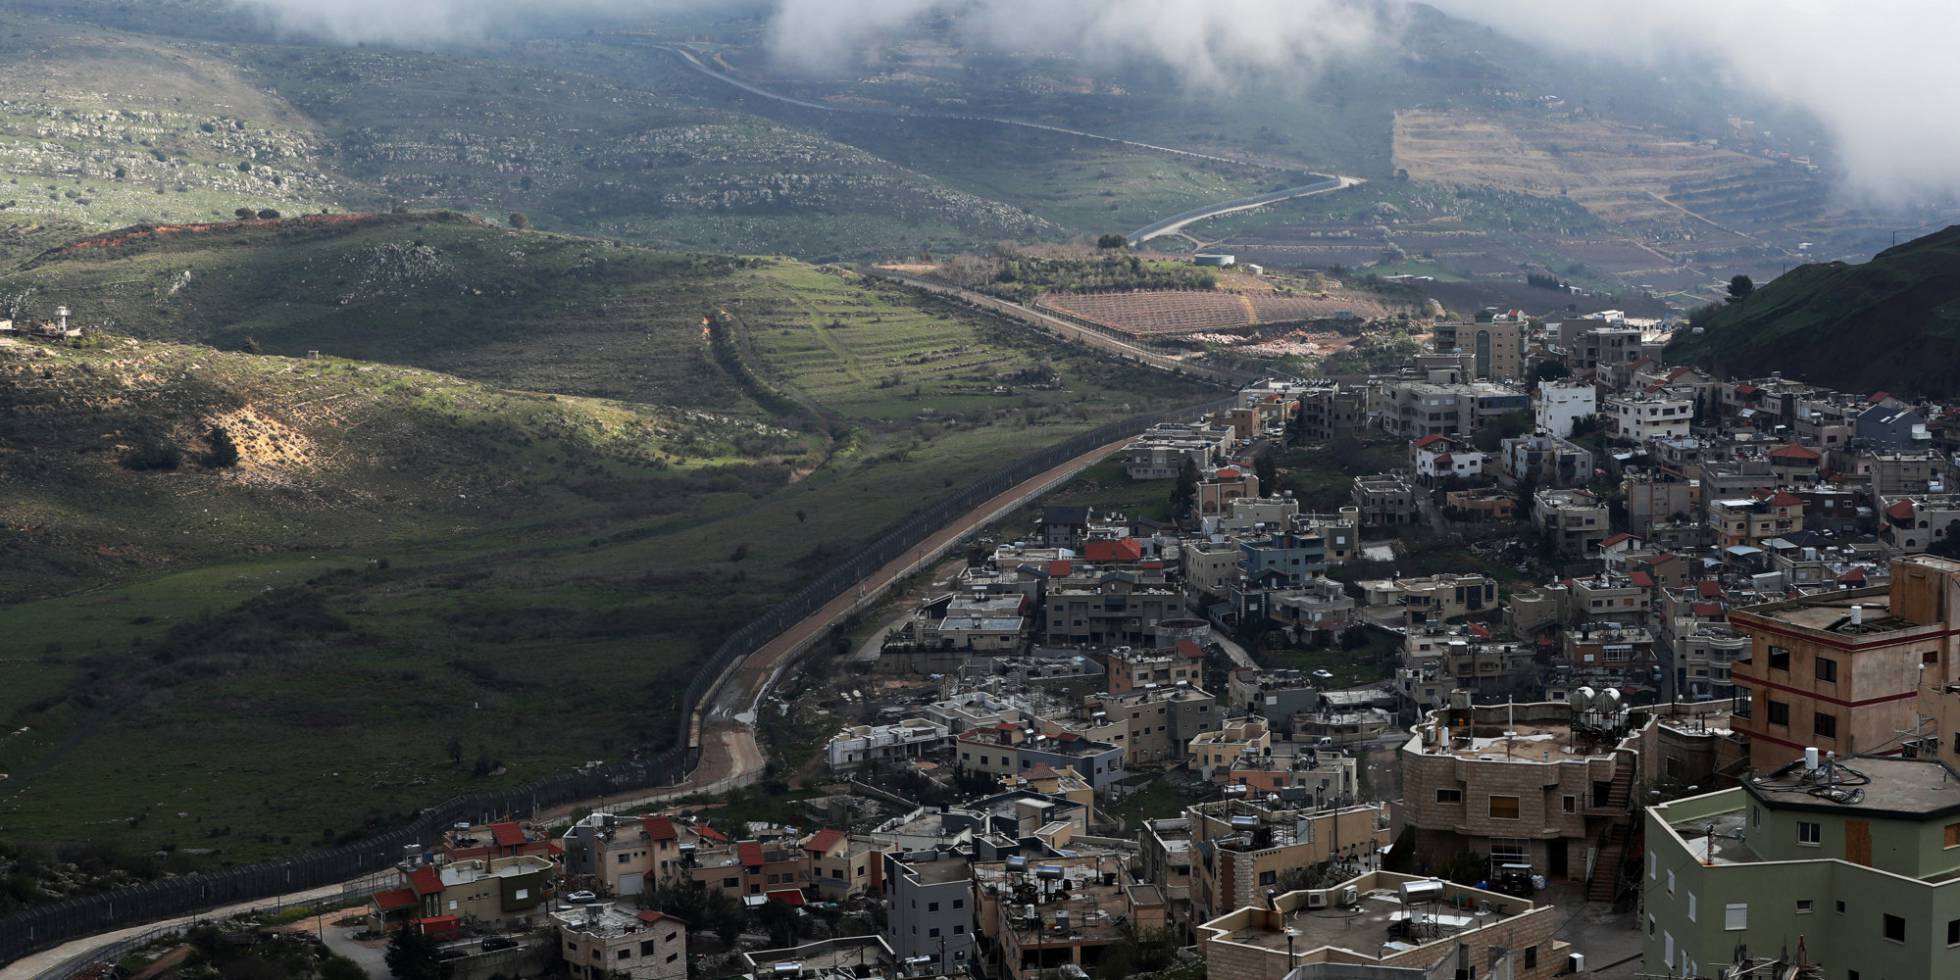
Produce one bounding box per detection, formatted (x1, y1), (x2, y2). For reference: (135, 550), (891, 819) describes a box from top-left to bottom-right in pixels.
(1037, 292), (1390, 335)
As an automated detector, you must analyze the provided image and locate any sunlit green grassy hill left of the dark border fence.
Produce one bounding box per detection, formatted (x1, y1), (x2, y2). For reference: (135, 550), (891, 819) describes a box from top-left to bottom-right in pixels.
(0, 216), (1209, 862)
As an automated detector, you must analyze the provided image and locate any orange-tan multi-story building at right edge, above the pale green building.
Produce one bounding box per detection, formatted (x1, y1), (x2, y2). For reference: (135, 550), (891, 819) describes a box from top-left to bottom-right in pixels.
(1729, 555), (1960, 770)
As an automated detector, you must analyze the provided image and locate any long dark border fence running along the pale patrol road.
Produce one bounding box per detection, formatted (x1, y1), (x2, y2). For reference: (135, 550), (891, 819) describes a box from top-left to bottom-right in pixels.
(0, 388), (1235, 964)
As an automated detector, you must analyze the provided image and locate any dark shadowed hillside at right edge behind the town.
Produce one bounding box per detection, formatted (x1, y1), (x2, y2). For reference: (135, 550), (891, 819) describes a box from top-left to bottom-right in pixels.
(1668, 225), (1960, 398)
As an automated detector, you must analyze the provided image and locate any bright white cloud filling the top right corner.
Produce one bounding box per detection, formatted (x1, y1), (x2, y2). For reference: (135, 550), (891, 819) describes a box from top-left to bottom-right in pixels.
(1437, 0), (1960, 206)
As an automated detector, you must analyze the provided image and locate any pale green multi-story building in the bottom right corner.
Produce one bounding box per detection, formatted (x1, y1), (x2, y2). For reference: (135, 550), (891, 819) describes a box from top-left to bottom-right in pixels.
(1641, 749), (1960, 980)
